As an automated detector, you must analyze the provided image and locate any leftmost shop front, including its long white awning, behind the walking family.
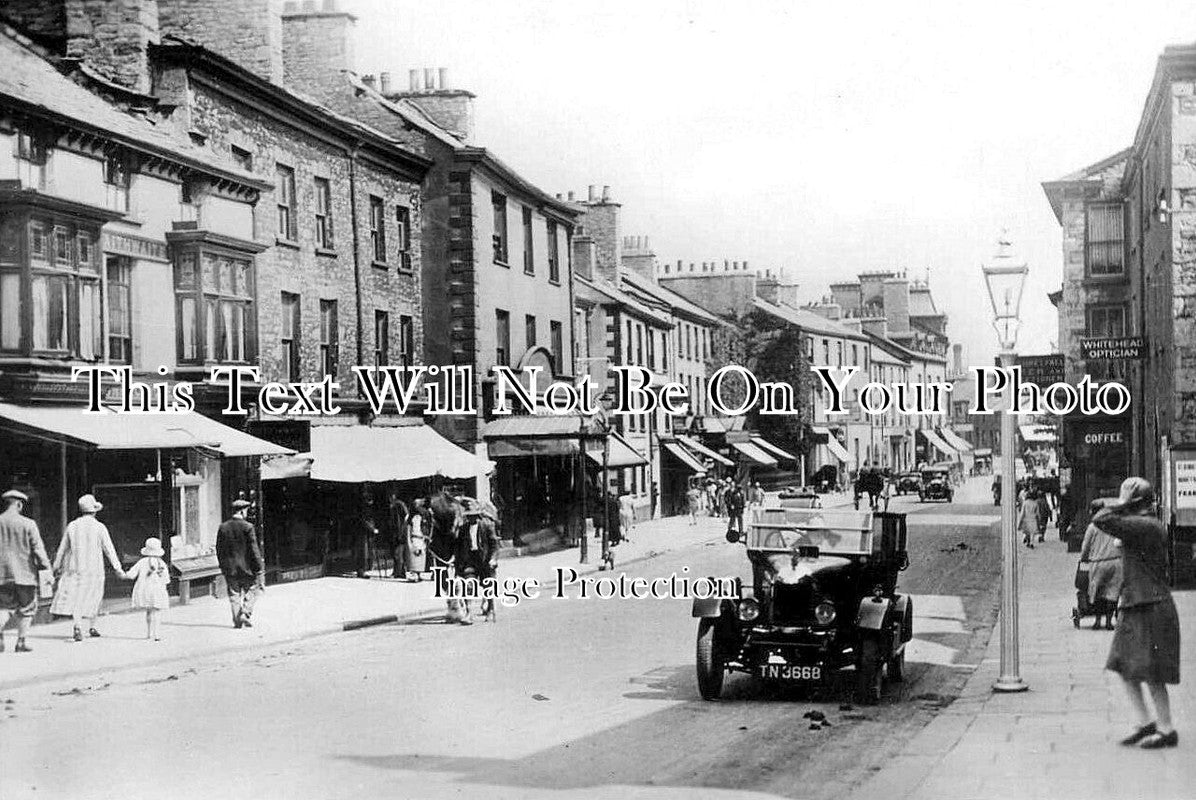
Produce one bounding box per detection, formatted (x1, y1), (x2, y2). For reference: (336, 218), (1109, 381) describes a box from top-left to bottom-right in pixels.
(0, 403), (288, 607)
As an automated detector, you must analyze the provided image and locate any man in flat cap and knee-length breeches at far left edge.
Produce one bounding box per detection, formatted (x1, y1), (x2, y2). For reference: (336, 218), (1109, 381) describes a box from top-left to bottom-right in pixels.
(0, 489), (50, 653)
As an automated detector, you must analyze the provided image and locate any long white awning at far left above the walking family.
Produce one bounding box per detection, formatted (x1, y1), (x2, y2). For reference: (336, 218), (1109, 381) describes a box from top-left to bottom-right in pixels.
(0, 403), (294, 457)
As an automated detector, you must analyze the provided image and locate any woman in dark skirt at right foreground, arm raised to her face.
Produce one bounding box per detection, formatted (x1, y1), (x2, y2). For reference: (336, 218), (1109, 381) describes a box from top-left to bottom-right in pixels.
(1092, 477), (1179, 750)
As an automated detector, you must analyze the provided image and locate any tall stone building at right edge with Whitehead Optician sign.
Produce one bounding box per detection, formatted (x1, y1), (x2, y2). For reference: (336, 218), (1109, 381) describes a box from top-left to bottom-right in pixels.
(1043, 44), (1196, 546)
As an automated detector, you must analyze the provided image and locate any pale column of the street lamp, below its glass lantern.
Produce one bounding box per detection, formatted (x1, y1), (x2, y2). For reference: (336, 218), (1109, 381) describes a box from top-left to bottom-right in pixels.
(993, 348), (1030, 691)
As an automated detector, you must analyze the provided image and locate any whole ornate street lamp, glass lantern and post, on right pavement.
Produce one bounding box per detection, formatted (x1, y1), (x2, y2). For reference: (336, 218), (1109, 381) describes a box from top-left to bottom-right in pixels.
(982, 234), (1030, 691)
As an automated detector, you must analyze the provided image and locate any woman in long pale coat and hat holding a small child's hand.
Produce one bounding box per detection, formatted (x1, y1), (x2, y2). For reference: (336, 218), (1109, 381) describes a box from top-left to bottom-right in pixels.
(50, 494), (126, 642)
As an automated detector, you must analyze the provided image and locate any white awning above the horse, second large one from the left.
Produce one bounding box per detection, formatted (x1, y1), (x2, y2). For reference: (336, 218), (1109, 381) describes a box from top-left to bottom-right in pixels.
(311, 425), (494, 483)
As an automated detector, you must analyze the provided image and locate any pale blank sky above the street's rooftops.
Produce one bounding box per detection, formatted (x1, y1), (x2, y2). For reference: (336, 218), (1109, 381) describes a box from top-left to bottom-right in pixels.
(349, 0), (1196, 365)
